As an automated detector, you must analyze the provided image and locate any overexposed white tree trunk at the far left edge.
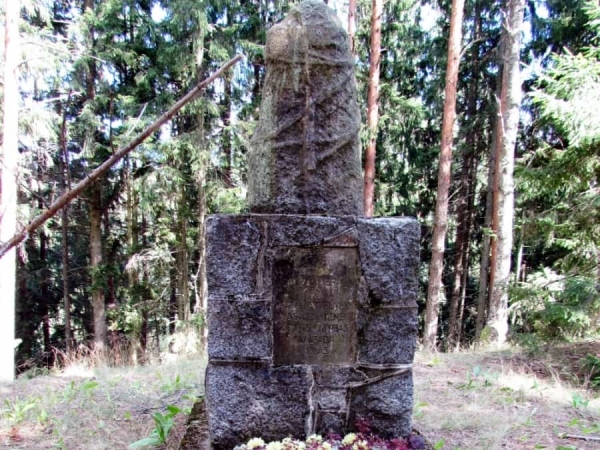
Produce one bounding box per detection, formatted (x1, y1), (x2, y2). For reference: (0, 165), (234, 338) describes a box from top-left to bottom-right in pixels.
(0, 0), (21, 382)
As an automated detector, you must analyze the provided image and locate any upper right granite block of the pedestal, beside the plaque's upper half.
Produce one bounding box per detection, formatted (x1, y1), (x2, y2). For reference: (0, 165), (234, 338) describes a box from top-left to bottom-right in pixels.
(357, 217), (421, 307)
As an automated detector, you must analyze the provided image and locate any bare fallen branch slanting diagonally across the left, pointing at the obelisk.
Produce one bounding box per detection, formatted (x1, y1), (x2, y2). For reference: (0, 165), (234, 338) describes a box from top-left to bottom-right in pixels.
(0, 55), (242, 258)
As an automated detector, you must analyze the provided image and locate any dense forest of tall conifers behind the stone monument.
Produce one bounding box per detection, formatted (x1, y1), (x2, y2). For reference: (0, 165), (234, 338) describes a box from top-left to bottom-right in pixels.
(0, 0), (600, 380)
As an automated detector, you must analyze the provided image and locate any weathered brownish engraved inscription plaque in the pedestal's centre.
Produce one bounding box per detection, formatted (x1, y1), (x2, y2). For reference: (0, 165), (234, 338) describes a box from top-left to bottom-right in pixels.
(273, 247), (360, 365)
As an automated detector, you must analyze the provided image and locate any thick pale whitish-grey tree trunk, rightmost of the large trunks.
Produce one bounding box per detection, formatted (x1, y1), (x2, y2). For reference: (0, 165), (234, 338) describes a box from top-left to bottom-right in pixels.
(488, 0), (525, 345)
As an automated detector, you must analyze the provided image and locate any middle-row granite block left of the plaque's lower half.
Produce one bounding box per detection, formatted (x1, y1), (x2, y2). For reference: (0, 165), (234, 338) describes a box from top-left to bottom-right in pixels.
(208, 298), (273, 360)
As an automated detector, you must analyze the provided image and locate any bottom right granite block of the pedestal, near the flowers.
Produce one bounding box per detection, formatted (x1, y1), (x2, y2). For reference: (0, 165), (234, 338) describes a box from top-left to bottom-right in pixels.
(349, 371), (413, 438)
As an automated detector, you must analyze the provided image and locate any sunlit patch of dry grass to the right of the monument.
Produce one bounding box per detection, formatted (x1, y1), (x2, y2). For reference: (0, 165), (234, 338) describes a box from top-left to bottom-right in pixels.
(414, 349), (600, 450)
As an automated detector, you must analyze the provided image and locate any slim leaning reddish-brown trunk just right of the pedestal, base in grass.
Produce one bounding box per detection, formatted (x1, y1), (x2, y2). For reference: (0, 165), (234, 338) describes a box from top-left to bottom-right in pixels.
(423, 0), (465, 350)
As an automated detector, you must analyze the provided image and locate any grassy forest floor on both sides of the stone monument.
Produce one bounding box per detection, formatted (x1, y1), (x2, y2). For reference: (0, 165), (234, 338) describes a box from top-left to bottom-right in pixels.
(0, 343), (600, 450)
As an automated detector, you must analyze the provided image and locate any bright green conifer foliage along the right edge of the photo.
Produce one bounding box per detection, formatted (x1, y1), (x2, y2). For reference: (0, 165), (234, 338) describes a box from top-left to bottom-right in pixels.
(511, 1), (600, 341)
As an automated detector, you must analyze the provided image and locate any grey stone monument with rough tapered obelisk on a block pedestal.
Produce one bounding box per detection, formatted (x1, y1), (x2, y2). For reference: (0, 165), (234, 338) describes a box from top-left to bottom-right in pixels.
(206, 0), (420, 450)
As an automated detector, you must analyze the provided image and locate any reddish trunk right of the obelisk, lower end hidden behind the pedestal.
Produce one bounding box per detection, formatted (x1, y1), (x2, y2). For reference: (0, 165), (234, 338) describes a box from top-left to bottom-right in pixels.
(363, 0), (383, 217)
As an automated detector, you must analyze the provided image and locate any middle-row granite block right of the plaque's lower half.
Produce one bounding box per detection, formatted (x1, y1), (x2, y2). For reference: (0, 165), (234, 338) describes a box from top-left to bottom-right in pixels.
(358, 308), (418, 364)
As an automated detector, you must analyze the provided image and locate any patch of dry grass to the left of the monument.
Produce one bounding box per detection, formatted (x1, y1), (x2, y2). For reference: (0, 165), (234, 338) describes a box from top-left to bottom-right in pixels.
(0, 356), (206, 450)
